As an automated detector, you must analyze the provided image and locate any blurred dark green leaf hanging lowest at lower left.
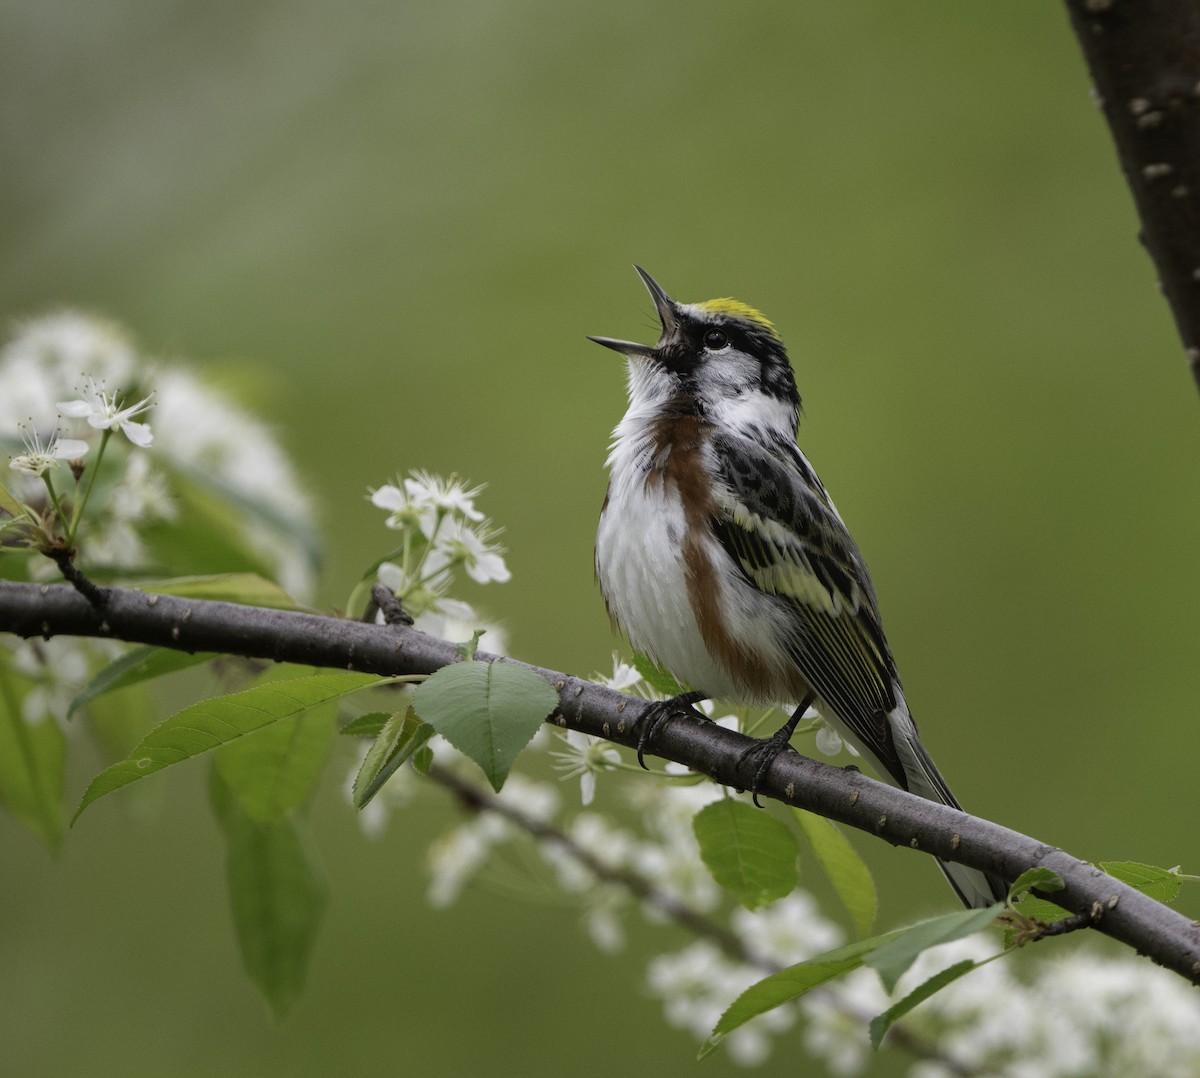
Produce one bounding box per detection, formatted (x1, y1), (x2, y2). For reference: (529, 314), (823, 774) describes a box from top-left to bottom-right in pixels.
(209, 767), (326, 1017)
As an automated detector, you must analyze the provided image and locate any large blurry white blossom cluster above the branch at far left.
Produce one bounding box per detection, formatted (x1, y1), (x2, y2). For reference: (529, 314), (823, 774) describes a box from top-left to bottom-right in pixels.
(0, 311), (314, 598)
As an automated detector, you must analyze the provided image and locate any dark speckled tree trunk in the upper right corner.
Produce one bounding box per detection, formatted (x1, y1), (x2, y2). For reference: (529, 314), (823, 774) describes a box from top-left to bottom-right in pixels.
(1067, 0), (1200, 385)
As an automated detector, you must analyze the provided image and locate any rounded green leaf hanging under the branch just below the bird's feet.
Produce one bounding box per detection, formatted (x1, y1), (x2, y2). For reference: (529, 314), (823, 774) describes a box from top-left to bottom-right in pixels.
(691, 797), (798, 910)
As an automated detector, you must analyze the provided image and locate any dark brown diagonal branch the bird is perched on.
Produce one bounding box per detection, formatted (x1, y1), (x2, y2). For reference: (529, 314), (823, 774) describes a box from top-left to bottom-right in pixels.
(7, 581), (1200, 984)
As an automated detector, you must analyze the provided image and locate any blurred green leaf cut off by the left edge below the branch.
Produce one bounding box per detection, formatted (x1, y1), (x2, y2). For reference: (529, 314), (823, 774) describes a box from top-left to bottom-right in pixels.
(0, 665), (66, 850)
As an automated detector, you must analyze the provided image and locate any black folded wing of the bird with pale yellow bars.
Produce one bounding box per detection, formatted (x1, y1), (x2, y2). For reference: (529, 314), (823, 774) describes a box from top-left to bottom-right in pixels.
(713, 435), (904, 780)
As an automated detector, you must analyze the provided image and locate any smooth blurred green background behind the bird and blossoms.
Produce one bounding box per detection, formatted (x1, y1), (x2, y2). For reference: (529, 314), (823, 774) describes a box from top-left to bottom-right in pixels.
(0, 0), (1200, 1078)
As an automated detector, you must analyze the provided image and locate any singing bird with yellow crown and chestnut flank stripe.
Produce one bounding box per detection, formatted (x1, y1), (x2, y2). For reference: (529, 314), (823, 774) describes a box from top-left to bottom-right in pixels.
(588, 266), (1008, 908)
